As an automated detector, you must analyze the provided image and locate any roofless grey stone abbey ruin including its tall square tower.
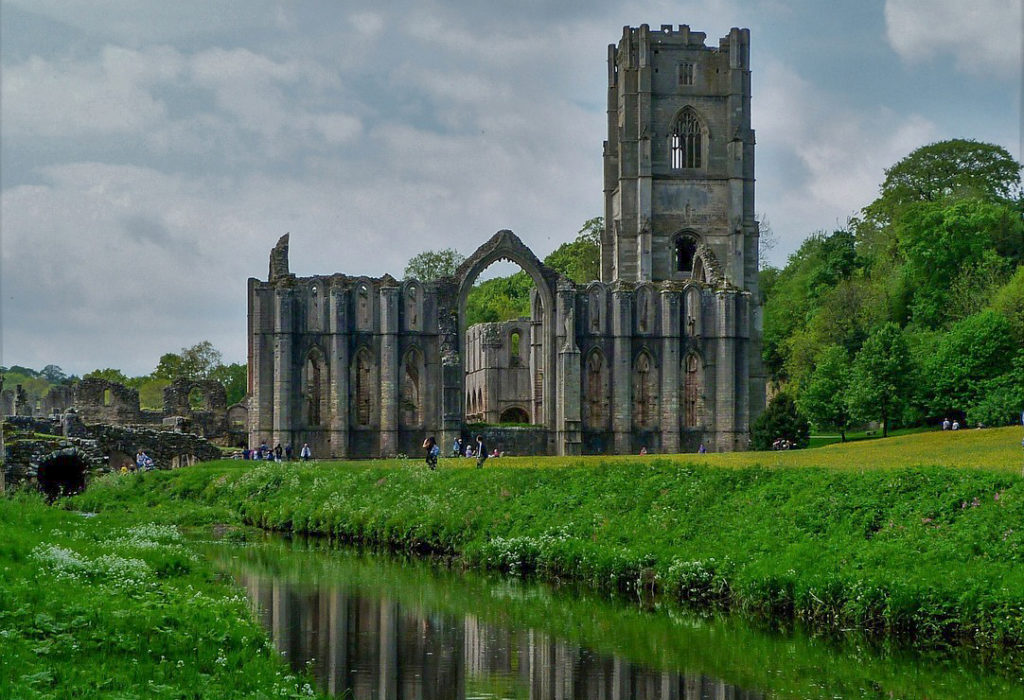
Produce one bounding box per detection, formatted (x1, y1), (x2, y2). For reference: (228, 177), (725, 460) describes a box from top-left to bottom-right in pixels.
(248, 25), (765, 457)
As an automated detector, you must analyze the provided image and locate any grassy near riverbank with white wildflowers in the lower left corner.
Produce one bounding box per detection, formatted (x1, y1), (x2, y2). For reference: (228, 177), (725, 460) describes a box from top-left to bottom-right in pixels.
(0, 494), (316, 698)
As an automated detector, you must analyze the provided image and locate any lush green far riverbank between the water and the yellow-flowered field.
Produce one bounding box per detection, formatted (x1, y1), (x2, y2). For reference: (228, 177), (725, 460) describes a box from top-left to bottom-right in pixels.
(77, 450), (1024, 656)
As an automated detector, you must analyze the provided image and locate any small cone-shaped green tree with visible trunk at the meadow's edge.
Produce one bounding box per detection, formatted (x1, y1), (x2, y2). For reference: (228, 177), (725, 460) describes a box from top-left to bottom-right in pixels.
(848, 322), (914, 437)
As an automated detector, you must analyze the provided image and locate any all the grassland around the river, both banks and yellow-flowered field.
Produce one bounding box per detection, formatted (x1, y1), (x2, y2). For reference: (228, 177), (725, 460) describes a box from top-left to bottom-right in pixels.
(0, 429), (1024, 698)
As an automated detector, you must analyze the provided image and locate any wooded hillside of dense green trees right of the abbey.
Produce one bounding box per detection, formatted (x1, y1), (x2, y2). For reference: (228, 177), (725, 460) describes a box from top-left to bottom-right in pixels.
(761, 139), (1024, 432)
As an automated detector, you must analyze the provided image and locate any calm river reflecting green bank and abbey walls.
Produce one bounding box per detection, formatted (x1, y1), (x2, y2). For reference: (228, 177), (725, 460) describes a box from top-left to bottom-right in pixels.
(208, 538), (1024, 700)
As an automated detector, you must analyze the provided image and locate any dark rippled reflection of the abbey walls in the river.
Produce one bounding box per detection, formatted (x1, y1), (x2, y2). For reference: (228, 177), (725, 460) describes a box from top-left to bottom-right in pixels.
(243, 576), (763, 700)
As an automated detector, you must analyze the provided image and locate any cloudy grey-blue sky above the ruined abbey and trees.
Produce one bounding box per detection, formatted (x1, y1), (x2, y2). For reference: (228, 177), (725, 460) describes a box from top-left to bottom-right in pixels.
(0, 0), (1022, 375)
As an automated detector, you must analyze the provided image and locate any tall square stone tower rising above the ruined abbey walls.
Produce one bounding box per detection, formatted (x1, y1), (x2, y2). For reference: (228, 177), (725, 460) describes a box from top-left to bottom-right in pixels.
(601, 25), (758, 295)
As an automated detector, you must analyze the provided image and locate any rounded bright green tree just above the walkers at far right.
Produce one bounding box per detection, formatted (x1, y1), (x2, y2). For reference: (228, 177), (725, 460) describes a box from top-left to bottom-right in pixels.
(927, 311), (1020, 414)
